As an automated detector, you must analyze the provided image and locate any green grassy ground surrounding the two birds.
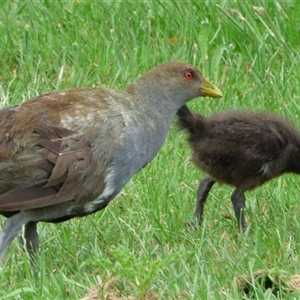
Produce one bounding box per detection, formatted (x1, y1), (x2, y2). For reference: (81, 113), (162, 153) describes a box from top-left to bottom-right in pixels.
(0, 0), (300, 300)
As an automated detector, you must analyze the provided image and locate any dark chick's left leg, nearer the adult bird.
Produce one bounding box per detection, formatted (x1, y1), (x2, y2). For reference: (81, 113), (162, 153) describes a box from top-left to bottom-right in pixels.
(187, 177), (215, 226)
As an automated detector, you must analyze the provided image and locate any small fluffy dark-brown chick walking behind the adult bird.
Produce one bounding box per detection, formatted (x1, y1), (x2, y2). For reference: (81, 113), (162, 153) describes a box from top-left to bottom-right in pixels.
(177, 105), (300, 230)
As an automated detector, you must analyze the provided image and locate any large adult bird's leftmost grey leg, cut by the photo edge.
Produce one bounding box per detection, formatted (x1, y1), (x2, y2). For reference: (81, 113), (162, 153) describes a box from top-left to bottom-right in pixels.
(0, 214), (29, 261)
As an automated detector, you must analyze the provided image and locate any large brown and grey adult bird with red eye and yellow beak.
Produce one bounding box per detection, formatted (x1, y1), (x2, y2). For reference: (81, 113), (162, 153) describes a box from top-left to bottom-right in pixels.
(0, 62), (222, 259)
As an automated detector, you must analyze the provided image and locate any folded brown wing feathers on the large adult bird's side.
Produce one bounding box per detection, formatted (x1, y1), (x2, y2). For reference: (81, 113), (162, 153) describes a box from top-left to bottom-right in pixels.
(0, 125), (98, 211)
